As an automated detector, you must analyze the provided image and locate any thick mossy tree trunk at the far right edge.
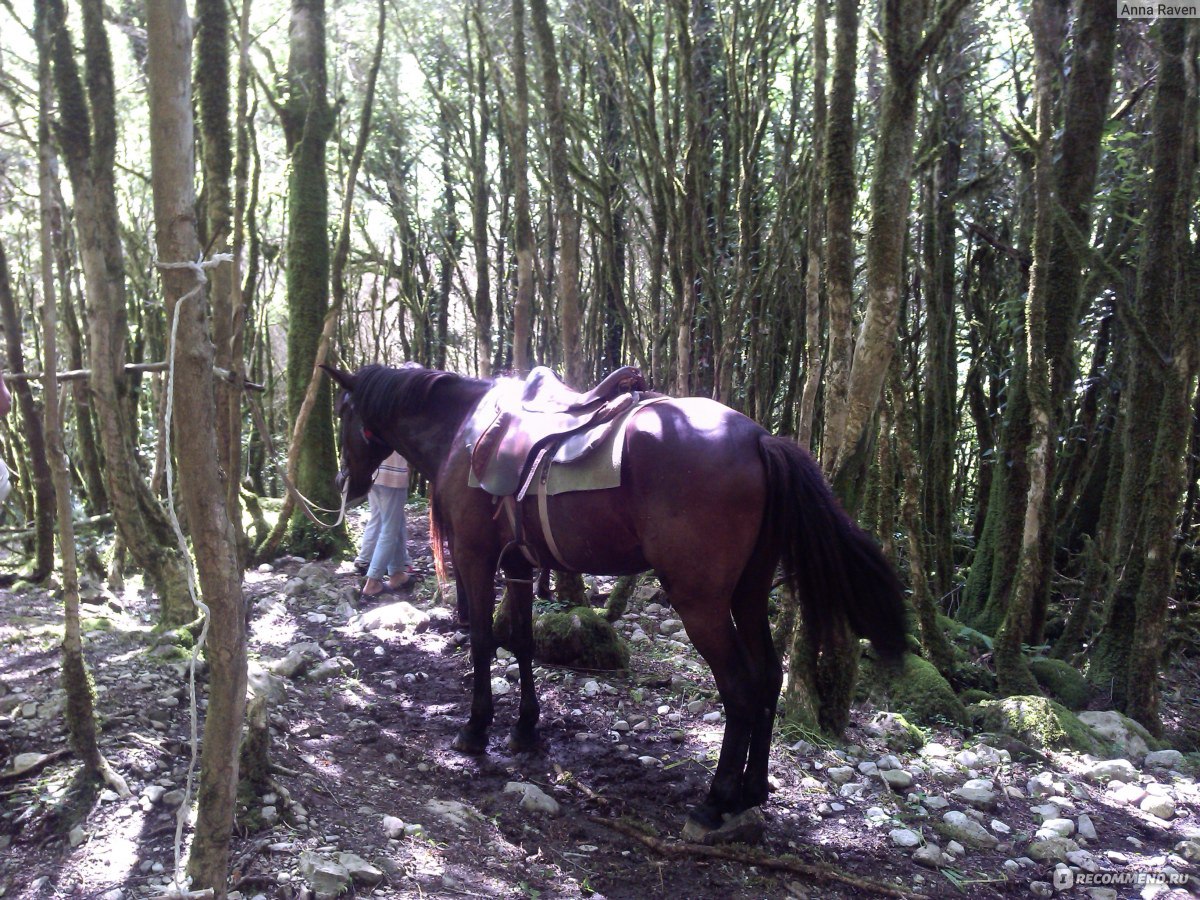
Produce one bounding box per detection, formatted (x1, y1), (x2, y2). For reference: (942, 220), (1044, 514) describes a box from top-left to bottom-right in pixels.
(1105, 19), (1198, 734)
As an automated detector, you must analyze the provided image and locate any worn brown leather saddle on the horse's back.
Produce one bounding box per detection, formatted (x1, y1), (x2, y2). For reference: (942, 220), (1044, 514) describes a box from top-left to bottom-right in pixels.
(466, 366), (646, 499)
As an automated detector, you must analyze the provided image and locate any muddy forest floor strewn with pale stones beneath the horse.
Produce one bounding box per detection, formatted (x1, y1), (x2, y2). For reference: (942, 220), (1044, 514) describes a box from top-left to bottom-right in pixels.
(0, 508), (1200, 900)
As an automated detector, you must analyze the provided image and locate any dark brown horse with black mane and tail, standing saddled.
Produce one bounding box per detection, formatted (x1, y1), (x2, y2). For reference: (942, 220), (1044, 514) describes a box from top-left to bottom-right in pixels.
(328, 366), (905, 829)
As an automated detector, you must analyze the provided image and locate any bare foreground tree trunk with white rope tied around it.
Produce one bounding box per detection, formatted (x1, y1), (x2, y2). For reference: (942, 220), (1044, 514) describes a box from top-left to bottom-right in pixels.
(146, 0), (246, 899)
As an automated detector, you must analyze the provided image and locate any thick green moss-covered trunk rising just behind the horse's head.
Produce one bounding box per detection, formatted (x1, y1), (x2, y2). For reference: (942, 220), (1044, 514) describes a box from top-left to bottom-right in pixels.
(282, 0), (347, 556)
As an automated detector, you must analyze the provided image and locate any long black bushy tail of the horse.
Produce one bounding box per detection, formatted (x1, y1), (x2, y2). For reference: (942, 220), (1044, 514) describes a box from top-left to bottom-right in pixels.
(758, 434), (907, 659)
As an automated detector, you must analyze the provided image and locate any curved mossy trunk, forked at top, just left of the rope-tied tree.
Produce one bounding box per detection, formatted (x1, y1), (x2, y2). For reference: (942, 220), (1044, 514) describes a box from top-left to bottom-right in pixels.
(47, 0), (196, 625)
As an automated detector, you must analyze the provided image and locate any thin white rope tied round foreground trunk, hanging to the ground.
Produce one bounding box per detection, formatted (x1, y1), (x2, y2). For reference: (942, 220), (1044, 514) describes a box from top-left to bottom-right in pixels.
(155, 253), (225, 898)
